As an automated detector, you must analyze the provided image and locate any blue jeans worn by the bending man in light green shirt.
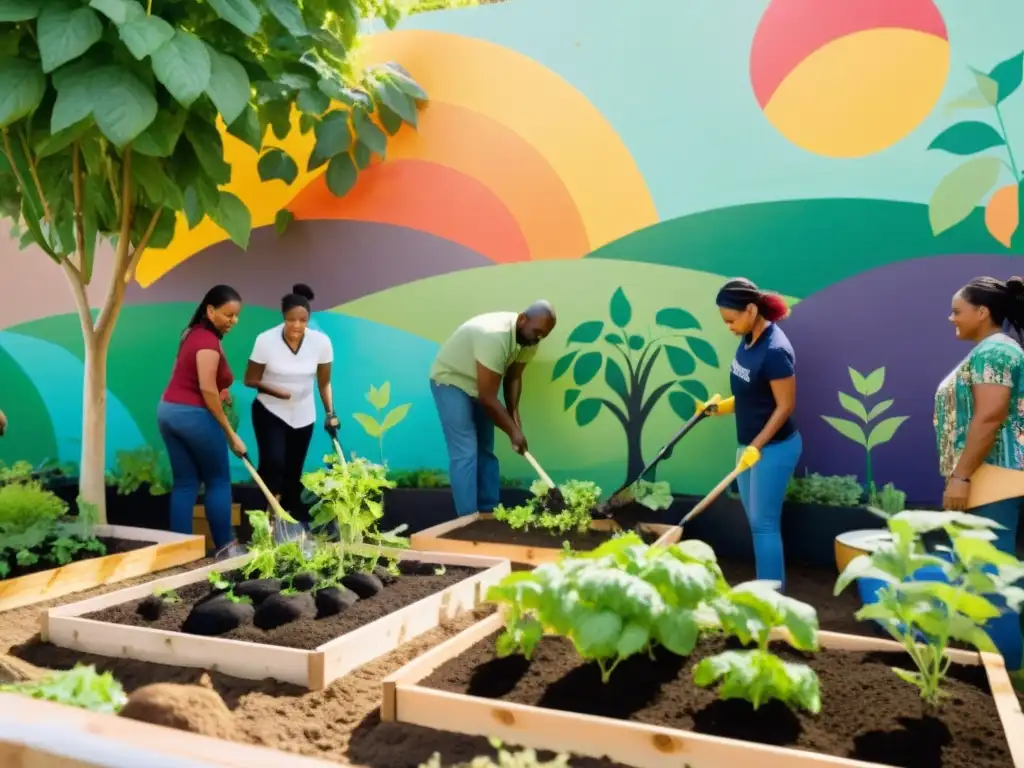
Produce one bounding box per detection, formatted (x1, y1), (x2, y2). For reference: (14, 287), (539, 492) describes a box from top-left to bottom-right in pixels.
(430, 381), (501, 516)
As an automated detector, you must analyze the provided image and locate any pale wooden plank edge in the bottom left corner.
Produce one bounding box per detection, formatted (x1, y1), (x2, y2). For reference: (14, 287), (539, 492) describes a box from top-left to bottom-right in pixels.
(0, 693), (337, 768)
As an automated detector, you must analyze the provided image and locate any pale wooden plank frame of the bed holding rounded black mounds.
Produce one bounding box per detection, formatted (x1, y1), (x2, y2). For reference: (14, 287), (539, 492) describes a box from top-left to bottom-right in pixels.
(40, 550), (511, 690)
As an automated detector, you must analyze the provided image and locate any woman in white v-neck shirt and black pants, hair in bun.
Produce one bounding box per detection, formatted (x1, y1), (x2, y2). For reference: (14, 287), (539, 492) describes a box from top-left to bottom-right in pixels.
(246, 284), (338, 519)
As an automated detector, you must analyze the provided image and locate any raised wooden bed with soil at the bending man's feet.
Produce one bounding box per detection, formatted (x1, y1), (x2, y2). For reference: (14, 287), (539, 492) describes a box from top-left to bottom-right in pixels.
(409, 512), (683, 565)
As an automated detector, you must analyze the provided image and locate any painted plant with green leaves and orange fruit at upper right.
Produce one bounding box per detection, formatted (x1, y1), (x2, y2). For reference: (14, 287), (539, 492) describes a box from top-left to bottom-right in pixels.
(928, 51), (1024, 248)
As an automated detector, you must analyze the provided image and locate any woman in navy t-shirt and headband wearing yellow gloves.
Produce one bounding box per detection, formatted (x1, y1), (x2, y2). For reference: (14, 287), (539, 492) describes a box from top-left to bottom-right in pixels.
(713, 278), (803, 583)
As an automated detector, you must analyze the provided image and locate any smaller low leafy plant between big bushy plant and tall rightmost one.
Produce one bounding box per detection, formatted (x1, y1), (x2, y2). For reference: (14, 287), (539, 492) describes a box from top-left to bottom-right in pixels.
(693, 581), (821, 714)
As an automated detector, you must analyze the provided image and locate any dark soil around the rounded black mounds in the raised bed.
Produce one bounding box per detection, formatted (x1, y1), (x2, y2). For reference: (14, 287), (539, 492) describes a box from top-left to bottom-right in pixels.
(84, 566), (478, 650)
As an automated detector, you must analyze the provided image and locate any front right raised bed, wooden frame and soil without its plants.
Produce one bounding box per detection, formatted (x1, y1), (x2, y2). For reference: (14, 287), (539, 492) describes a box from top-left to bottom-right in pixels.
(381, 614), (1024, 768)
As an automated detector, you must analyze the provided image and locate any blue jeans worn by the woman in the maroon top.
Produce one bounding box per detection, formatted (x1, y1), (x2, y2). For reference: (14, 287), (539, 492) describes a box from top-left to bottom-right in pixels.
(157, 401), (234, 549)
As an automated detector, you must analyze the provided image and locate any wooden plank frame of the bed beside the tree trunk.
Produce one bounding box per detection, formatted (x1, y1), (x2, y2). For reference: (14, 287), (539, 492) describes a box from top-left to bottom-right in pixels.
(0, 525), (206, 612)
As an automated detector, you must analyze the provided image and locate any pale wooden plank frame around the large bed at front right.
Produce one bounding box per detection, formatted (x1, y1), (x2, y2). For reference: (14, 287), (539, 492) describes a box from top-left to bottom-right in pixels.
(381, 613), (1024, 768)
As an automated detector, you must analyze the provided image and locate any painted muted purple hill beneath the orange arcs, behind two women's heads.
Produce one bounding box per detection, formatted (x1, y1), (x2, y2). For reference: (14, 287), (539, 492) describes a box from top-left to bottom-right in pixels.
(126, 220), (493, 309)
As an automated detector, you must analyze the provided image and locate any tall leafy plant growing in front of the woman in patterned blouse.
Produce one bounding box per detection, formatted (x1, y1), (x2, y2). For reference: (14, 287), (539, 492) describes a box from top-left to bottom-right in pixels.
(835, 510), (1024, 705)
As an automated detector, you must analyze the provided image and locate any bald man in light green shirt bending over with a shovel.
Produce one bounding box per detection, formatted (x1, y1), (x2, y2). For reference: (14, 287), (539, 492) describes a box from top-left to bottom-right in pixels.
(430, 301), (555, 515)
